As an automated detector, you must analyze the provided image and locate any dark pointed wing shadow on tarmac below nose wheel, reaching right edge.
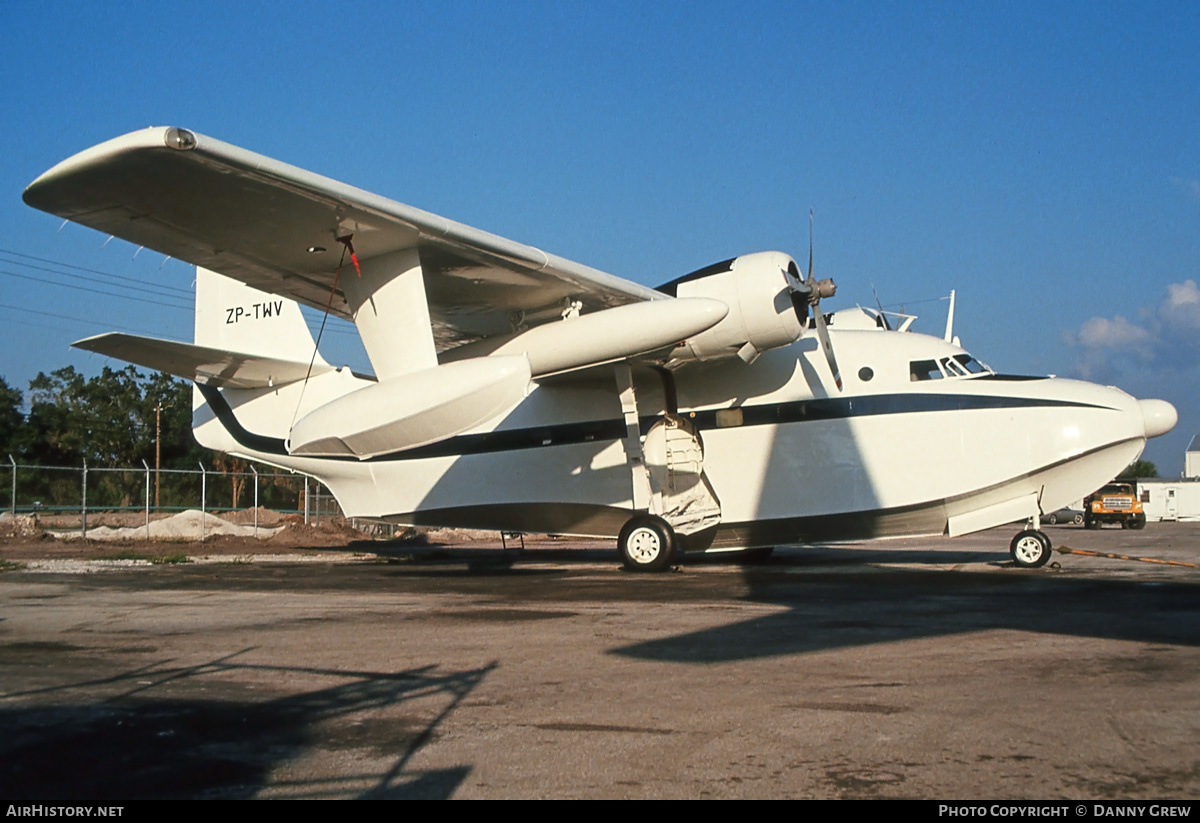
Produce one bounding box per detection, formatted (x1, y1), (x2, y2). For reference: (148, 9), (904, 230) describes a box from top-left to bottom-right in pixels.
(612, 549), (1200, 663)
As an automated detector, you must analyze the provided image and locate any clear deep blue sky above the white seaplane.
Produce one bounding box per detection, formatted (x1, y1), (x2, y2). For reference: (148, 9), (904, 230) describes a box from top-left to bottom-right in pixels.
(0, 0), (1200, 474)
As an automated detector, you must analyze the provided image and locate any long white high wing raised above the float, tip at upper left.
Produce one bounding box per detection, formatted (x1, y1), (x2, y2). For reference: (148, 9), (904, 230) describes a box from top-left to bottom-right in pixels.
(24, 127), (670, 350)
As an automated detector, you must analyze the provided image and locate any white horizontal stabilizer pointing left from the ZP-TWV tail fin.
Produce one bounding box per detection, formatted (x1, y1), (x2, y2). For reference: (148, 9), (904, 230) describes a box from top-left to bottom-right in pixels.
(71, 331), (334, 389)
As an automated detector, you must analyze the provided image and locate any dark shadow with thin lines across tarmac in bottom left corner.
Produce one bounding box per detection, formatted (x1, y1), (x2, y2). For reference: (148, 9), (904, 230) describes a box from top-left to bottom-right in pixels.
(0, 649), (496, 800)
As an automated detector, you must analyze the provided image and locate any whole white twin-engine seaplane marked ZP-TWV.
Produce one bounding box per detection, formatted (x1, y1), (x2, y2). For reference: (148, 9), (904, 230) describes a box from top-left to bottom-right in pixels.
(24, 127), (1176, 571)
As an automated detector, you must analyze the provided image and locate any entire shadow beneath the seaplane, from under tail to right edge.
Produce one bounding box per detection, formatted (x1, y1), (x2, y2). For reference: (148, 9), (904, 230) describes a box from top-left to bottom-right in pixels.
(307, 537), (1200, 663)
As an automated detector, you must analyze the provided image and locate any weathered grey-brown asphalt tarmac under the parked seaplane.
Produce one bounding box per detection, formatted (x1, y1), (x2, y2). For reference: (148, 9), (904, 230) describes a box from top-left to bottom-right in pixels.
(0, 523), (1200, 800)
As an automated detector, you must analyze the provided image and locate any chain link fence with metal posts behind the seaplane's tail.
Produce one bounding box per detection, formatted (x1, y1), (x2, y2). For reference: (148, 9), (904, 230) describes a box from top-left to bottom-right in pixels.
(0, 455), (342, 536)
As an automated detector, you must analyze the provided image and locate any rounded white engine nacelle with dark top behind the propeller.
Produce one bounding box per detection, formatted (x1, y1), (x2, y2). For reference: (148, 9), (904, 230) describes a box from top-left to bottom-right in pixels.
(660, 252), (809, 362)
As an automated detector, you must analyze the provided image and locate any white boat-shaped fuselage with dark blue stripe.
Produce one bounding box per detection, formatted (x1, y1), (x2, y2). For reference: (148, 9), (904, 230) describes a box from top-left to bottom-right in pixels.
(197, 330), (1158, 551)
